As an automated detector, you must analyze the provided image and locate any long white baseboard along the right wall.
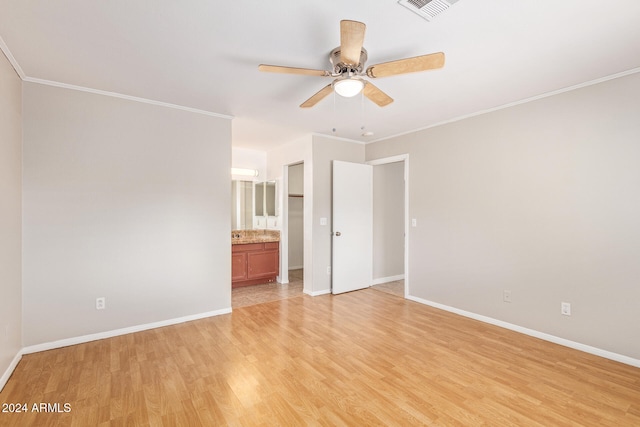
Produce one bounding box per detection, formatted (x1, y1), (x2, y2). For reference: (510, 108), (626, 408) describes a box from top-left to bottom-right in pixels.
(407, 295), (640, 368)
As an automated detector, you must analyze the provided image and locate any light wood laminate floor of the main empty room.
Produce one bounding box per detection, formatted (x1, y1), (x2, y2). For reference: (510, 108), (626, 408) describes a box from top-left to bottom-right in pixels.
(0, 289), (640, 427)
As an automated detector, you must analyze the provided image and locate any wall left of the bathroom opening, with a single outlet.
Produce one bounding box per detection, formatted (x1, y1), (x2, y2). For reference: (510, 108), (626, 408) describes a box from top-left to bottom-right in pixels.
(23, 83), (231, 346)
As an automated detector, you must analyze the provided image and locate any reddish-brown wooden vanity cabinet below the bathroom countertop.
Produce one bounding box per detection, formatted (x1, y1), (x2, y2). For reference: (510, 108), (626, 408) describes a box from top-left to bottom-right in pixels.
(231, 242), (280, 288)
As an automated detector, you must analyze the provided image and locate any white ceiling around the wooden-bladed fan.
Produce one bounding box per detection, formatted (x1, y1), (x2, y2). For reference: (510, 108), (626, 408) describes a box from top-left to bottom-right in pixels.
(0, 0), (640, 150)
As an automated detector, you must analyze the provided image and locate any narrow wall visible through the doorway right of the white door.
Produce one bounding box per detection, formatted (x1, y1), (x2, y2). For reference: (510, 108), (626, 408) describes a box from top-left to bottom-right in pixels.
(373, 162), (404, 283)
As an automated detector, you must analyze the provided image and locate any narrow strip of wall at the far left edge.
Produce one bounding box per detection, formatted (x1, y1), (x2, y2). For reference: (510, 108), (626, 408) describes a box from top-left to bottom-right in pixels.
(0, 51), (22, 389)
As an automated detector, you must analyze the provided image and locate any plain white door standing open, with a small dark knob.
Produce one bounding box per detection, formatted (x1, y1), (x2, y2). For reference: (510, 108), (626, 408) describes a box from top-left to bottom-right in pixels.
(332, 160), (373, 294)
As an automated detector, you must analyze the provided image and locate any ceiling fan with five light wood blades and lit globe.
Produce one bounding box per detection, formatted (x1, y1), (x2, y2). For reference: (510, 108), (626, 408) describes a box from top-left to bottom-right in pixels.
(258, 20), (444, 108)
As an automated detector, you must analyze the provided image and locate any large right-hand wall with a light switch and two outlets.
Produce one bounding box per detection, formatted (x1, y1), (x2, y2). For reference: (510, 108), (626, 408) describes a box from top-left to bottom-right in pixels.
(367, 70), (640, 359)
